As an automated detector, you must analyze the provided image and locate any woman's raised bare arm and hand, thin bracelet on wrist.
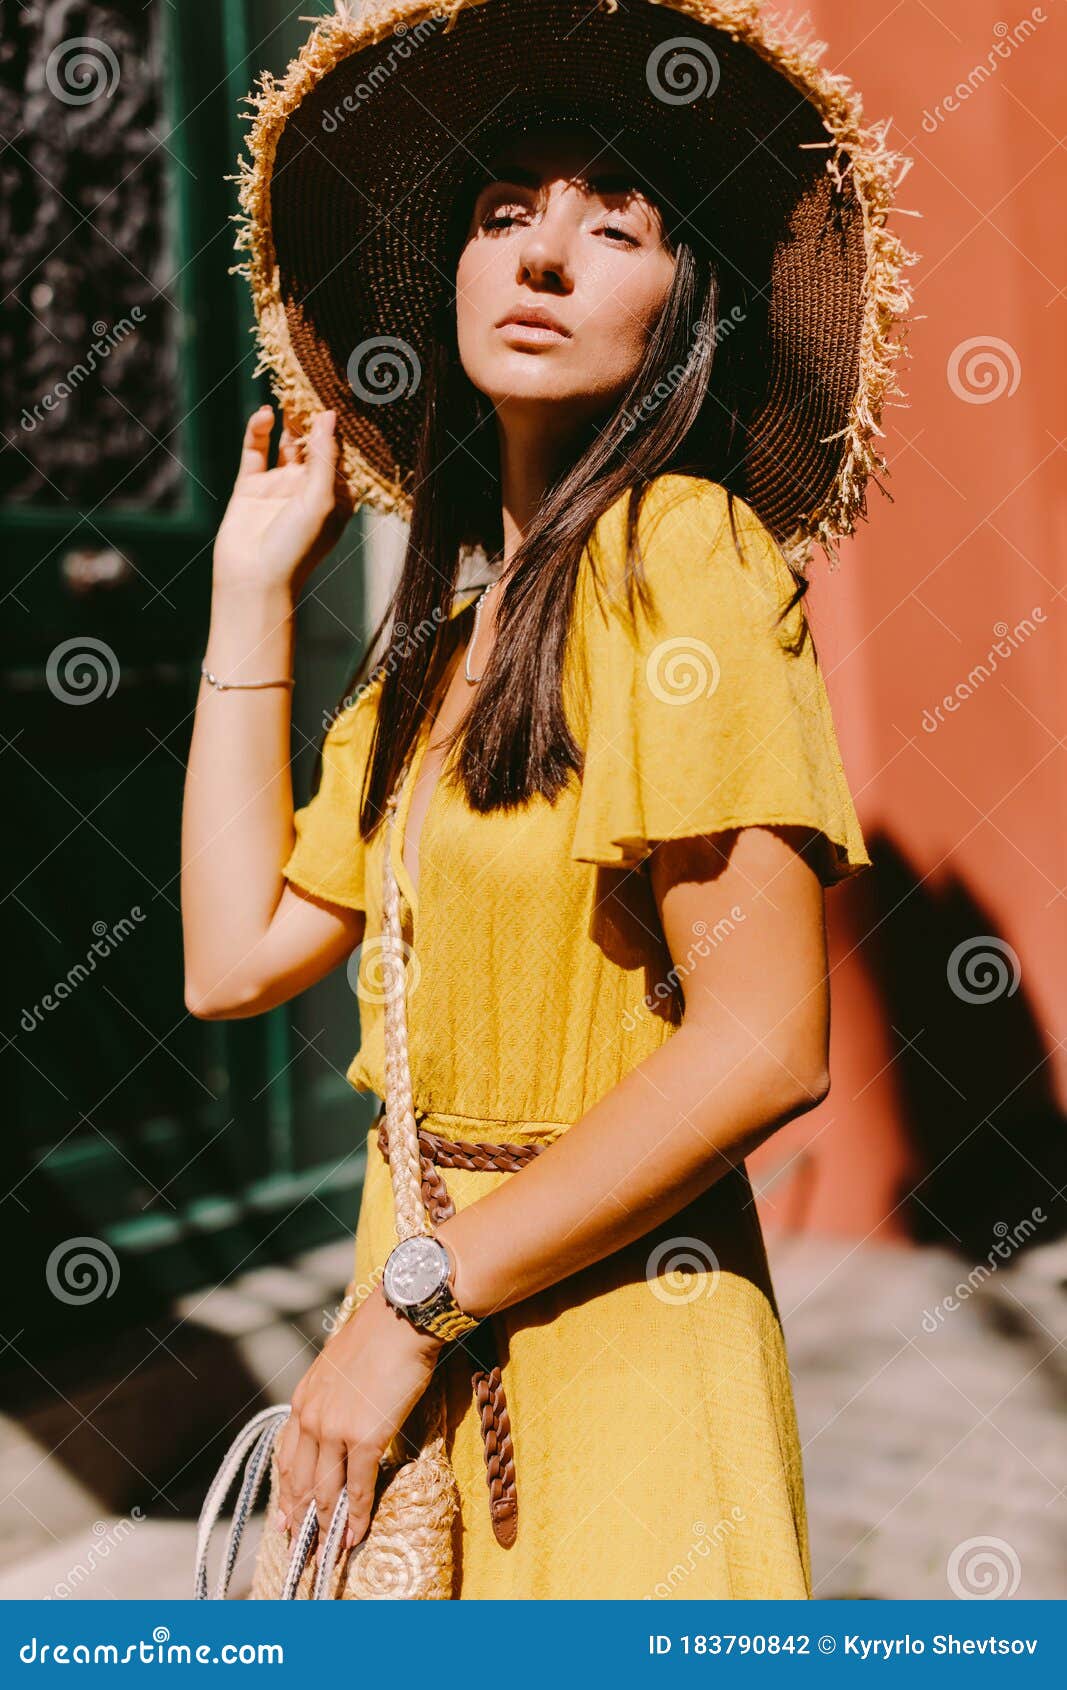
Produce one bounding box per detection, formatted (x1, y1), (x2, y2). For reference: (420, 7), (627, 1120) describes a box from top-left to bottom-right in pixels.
(181, 406), (364, 1019)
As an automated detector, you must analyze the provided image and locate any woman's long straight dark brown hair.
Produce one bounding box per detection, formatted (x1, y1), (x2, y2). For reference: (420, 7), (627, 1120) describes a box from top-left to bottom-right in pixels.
(316, 133), (808, 838)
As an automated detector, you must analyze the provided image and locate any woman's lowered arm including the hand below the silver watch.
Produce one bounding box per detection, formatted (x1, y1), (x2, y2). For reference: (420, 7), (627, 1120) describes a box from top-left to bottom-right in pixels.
(276, 826), (829, 1543)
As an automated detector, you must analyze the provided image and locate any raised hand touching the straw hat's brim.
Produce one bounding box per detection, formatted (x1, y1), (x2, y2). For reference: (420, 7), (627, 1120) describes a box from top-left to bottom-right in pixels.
(213, 406), (353, 597)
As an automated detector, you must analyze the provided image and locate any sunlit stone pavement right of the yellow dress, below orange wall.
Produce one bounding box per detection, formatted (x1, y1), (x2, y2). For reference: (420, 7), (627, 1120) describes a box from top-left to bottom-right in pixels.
(768, 1239), (1067, 1599)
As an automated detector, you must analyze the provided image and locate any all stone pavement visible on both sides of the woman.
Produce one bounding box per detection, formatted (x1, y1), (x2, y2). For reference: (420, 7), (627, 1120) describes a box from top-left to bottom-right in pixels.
(0, 1237), (1067, 1600)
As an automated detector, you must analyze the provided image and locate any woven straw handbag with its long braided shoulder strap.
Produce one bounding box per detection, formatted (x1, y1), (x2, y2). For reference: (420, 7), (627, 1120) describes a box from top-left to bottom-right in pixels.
(194, 764), (458, 1600)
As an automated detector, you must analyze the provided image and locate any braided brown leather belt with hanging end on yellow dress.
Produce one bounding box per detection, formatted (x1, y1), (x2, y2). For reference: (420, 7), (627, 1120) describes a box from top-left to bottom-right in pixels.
(377, 1109), (546, 1550)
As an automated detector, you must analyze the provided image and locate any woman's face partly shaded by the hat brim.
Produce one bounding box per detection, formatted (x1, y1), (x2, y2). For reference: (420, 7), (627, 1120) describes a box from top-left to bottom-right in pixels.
(457, 128), (675, 426)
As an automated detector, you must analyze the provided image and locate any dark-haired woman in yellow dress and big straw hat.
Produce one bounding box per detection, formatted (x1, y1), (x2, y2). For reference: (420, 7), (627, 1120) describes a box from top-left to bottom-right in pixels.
(183, 3), (913, 1599)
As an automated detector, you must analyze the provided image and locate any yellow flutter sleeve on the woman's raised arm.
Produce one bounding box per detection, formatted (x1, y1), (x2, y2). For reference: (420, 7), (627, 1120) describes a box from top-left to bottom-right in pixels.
(282, 683), (380, 909)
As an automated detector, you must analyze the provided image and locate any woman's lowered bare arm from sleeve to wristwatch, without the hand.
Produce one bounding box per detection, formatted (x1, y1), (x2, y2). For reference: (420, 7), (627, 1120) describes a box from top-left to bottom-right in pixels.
(438, 828), (829, 1317)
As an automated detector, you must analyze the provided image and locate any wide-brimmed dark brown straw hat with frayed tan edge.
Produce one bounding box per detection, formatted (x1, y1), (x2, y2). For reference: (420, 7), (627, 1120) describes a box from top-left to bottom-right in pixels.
(232, 0), (913, 566)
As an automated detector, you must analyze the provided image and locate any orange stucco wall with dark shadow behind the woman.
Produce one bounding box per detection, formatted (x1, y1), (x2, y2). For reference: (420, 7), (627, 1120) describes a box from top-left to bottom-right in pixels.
(749, 0), (1067, 1244)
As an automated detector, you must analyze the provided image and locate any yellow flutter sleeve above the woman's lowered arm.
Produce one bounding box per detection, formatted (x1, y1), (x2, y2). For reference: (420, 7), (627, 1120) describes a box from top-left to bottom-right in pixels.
(572, 475), (871, 886)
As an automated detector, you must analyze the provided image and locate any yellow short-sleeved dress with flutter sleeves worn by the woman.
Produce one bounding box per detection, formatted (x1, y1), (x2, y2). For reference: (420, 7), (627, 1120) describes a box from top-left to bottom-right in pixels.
(284, 475), (869, 1599)
